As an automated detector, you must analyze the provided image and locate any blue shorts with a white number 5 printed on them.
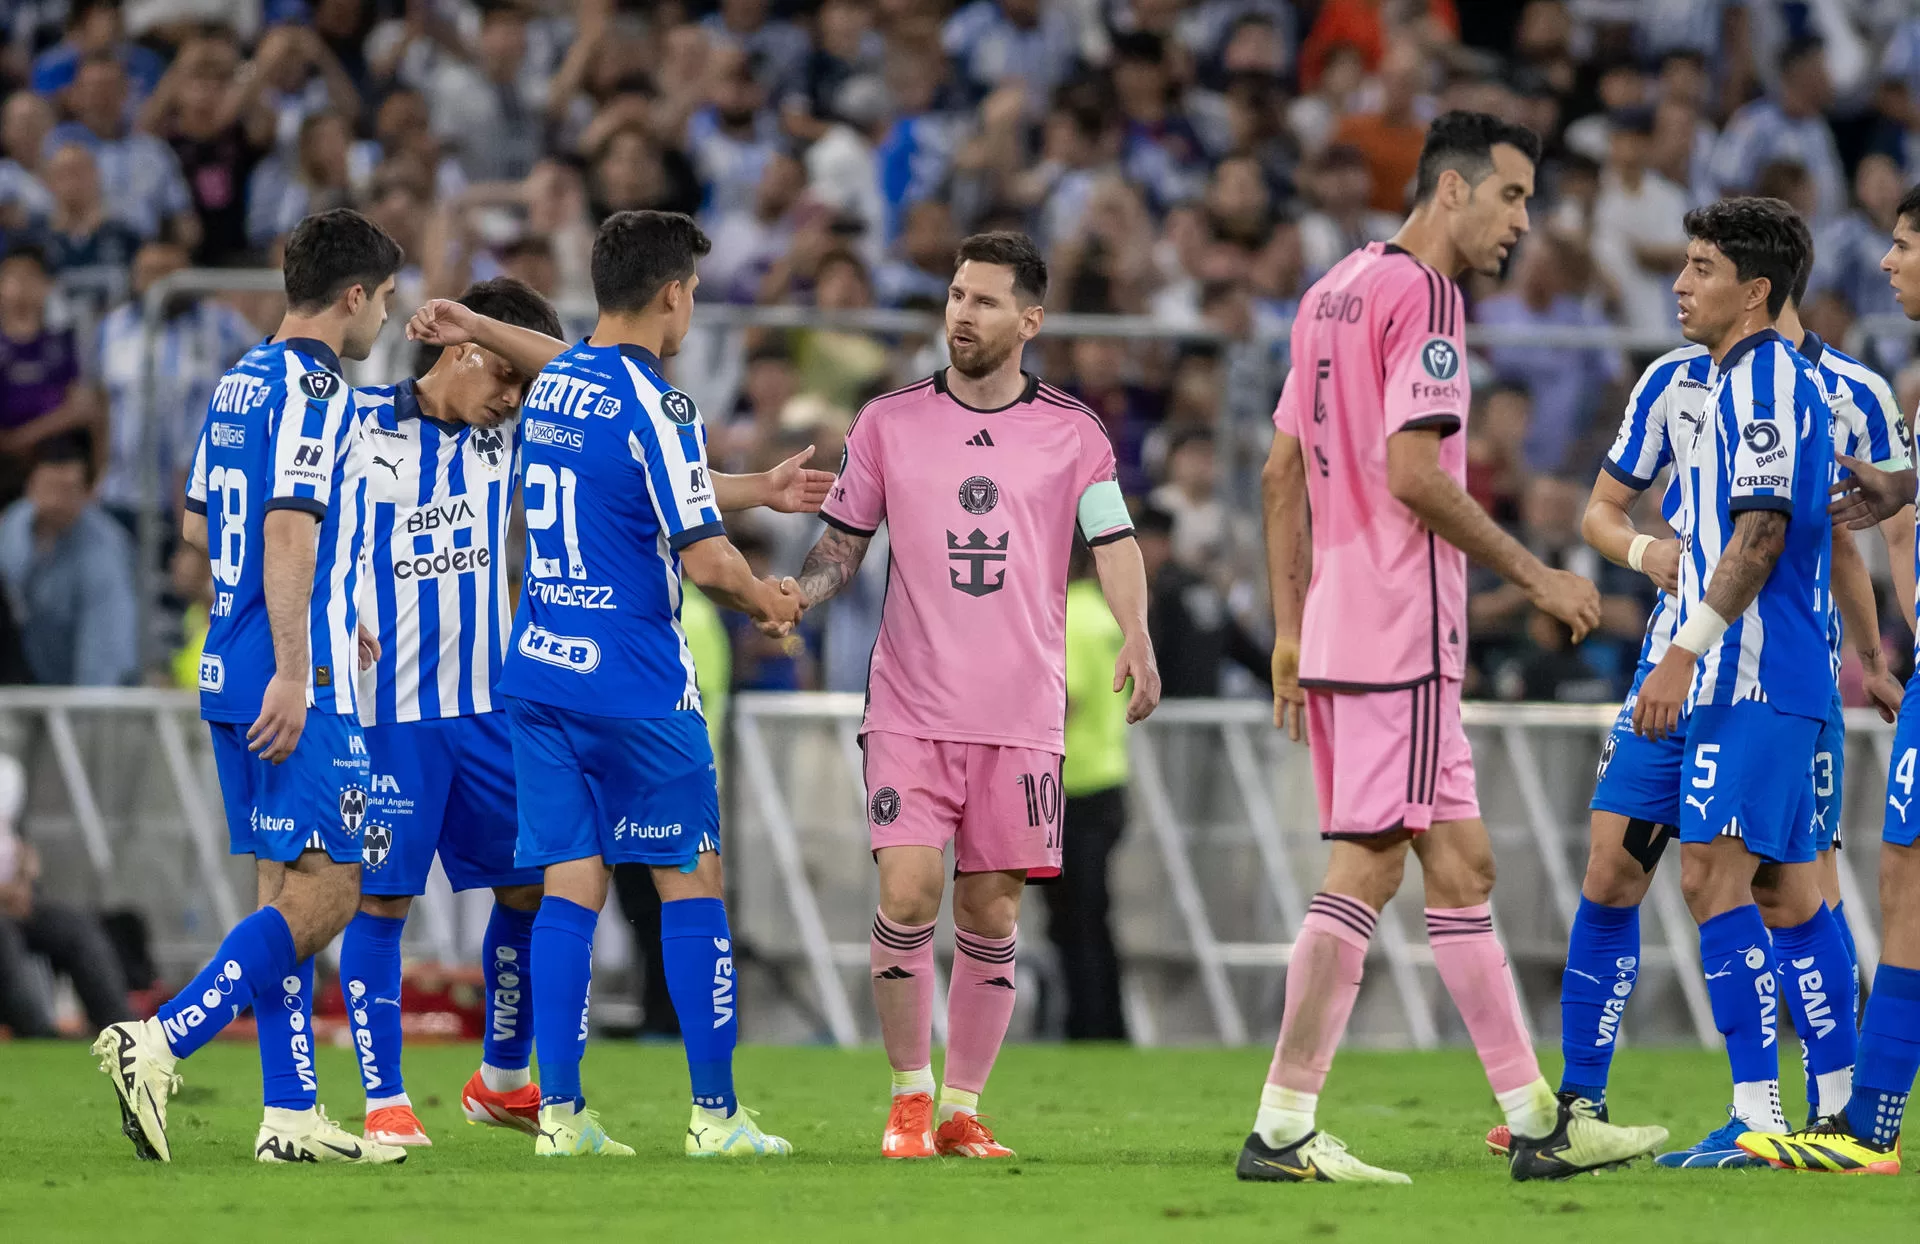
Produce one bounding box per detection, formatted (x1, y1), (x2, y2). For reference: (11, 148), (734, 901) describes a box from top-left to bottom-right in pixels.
(1680, 701), (1822, 864)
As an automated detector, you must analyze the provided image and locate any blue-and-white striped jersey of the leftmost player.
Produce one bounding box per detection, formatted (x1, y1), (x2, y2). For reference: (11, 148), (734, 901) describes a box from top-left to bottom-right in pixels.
(186, 338), (367, 722)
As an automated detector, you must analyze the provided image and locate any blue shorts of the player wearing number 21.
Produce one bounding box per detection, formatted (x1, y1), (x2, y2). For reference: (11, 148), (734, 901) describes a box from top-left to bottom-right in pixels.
(507, 699), (720, 872)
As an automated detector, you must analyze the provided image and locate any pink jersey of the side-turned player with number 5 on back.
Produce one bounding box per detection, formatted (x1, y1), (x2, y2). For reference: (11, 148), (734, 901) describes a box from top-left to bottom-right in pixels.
(1273, 242), (1467, 691)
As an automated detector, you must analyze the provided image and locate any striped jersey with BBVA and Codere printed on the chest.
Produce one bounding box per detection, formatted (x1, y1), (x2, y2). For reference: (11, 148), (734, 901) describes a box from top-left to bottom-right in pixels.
(353, 380), (518, 726)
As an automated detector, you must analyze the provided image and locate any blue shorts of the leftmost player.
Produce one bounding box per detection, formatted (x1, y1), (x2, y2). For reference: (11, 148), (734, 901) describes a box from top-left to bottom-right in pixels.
(207, 708), (369, 864)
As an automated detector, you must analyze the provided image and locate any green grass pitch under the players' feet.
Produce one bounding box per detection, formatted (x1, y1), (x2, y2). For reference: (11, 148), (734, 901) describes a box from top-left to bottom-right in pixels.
(0, 1042), (1920, 1244)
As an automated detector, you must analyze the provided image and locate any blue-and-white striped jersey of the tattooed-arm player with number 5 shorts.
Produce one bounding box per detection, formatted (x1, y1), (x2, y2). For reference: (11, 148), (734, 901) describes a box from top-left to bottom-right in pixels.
(1672, 328), (1834, 718)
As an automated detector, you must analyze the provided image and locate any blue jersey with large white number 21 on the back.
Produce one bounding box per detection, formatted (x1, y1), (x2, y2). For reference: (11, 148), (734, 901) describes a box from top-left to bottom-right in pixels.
(499, 342), (726, 718)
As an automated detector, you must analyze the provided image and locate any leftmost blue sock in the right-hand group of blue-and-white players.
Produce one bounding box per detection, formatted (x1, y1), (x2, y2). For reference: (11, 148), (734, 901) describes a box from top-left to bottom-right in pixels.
(1561, 895), (1640, 1106)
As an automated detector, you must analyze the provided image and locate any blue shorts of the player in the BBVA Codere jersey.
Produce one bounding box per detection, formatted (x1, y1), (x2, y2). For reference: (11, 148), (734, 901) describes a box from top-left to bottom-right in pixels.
(361, 712), (540, 897)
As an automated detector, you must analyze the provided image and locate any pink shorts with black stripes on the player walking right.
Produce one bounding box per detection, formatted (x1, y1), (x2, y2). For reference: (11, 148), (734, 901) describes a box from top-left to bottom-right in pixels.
(1308, 678), (1480, 839)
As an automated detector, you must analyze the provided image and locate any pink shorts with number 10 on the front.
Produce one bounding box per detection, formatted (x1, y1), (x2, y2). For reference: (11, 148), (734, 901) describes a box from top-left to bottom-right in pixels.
(862, 731), (1060, 879)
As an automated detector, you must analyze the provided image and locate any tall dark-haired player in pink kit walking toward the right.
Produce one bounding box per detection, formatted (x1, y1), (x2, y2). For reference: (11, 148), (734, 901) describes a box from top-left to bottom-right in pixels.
(1238, 111), (1667, 1183)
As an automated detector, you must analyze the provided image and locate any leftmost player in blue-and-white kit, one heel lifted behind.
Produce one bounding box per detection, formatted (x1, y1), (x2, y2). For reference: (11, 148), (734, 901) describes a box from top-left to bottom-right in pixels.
(94, 209), (405, 1163)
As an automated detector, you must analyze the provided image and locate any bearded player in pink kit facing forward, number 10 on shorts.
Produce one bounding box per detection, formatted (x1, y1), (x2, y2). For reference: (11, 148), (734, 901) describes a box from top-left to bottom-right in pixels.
(801, 232), (1160, 1158)
